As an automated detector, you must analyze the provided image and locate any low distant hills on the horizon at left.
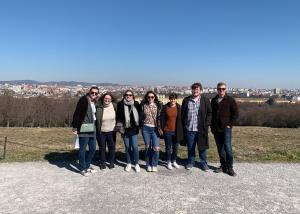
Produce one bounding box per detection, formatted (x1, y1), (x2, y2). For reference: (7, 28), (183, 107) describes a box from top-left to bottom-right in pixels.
(0, 80), (120, 86)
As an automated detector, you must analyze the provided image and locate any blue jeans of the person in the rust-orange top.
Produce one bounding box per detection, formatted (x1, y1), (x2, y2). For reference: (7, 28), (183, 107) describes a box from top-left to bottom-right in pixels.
(164, 131), (178, 162)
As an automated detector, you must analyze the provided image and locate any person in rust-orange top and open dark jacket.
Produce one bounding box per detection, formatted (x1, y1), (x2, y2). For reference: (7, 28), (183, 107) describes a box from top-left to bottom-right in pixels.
(160, 93), (183, 170)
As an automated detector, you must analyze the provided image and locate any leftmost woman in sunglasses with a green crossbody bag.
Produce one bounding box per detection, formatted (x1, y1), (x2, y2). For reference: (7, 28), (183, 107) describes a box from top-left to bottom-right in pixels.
(72, 87), (99, 176)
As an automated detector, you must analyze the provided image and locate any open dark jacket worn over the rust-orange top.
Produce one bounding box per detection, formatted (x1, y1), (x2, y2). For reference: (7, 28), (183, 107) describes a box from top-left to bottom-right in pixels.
(160, 103), (183, 142)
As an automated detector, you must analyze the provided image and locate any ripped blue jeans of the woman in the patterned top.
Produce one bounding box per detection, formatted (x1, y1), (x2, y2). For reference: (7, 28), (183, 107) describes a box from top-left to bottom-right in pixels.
(142, 126), (160, 166)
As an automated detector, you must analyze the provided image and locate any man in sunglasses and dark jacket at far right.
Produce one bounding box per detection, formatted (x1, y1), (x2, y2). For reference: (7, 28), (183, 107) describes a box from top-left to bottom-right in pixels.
(211, 82), (238, 176)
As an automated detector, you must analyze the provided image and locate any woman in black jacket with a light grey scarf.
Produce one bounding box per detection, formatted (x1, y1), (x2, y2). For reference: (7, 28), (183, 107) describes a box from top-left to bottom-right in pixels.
(116, 90), (140, 172)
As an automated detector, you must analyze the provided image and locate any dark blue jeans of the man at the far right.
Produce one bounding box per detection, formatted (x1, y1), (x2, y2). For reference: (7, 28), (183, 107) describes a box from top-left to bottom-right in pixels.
(214, 128), (233, 169)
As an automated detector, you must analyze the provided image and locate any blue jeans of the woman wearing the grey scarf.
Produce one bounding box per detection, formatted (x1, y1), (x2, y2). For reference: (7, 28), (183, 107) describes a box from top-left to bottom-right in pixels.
(123, 134), (139, 165)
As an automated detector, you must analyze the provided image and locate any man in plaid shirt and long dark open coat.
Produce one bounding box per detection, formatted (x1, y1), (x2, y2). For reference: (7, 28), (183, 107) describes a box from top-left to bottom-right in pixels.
(181, 83), (211, 171)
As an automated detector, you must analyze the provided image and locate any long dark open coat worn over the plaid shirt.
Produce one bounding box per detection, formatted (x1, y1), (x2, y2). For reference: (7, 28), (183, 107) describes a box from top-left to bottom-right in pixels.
(181, 95), (212, 150)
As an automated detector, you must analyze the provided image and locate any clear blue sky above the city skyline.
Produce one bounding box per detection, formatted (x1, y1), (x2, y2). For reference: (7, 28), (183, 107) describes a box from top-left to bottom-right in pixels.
(0, 0), (300, 88)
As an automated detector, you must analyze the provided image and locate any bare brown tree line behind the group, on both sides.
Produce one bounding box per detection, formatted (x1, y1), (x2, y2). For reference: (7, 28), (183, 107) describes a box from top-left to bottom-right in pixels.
(0, 91), (300, 128)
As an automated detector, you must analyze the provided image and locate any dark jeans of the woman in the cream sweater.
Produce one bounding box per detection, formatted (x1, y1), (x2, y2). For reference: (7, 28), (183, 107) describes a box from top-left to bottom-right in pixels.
(97, 132), (116, 165)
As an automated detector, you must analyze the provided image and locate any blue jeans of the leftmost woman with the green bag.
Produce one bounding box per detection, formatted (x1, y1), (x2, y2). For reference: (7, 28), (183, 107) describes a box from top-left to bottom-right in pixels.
(79, 137), (96, 170)
